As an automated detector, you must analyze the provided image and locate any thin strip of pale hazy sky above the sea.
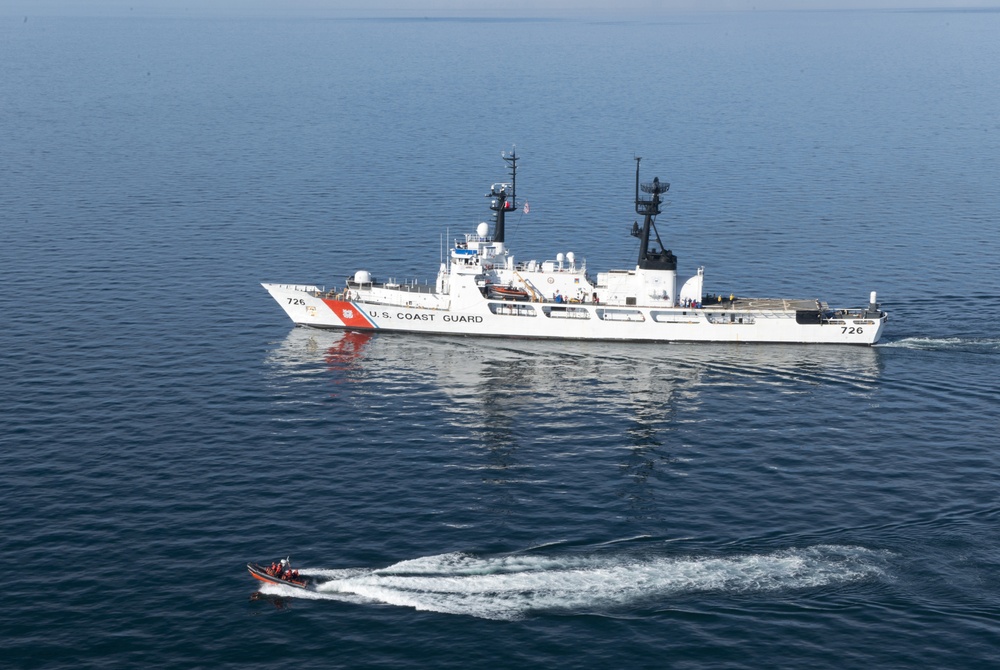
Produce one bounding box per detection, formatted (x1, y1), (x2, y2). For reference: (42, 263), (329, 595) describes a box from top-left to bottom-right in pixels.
(0, 0), (1000, 17)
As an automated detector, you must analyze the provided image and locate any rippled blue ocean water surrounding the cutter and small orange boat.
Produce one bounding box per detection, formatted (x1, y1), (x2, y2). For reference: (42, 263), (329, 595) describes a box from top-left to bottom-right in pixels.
(0, 6), (1000, 668)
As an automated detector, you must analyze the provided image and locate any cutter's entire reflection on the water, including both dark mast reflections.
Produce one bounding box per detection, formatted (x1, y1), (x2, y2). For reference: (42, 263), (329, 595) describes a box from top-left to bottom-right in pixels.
(269, 328), (882, 516)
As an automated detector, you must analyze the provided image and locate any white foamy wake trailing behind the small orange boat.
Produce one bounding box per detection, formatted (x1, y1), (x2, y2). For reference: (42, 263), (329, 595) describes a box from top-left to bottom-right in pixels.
(254, 545), (885, 620)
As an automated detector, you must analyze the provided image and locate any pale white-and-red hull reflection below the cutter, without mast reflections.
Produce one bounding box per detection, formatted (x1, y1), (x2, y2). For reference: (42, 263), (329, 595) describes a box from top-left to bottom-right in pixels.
(268, 327), (881, 406)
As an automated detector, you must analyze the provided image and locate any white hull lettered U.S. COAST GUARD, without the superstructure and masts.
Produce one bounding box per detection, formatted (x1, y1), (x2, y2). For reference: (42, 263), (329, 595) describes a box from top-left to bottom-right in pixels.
(262, 283), (887, 345)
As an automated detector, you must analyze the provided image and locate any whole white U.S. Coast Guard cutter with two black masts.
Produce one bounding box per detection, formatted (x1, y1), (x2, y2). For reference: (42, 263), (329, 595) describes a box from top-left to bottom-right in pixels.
(263, 151), (888, 345)
